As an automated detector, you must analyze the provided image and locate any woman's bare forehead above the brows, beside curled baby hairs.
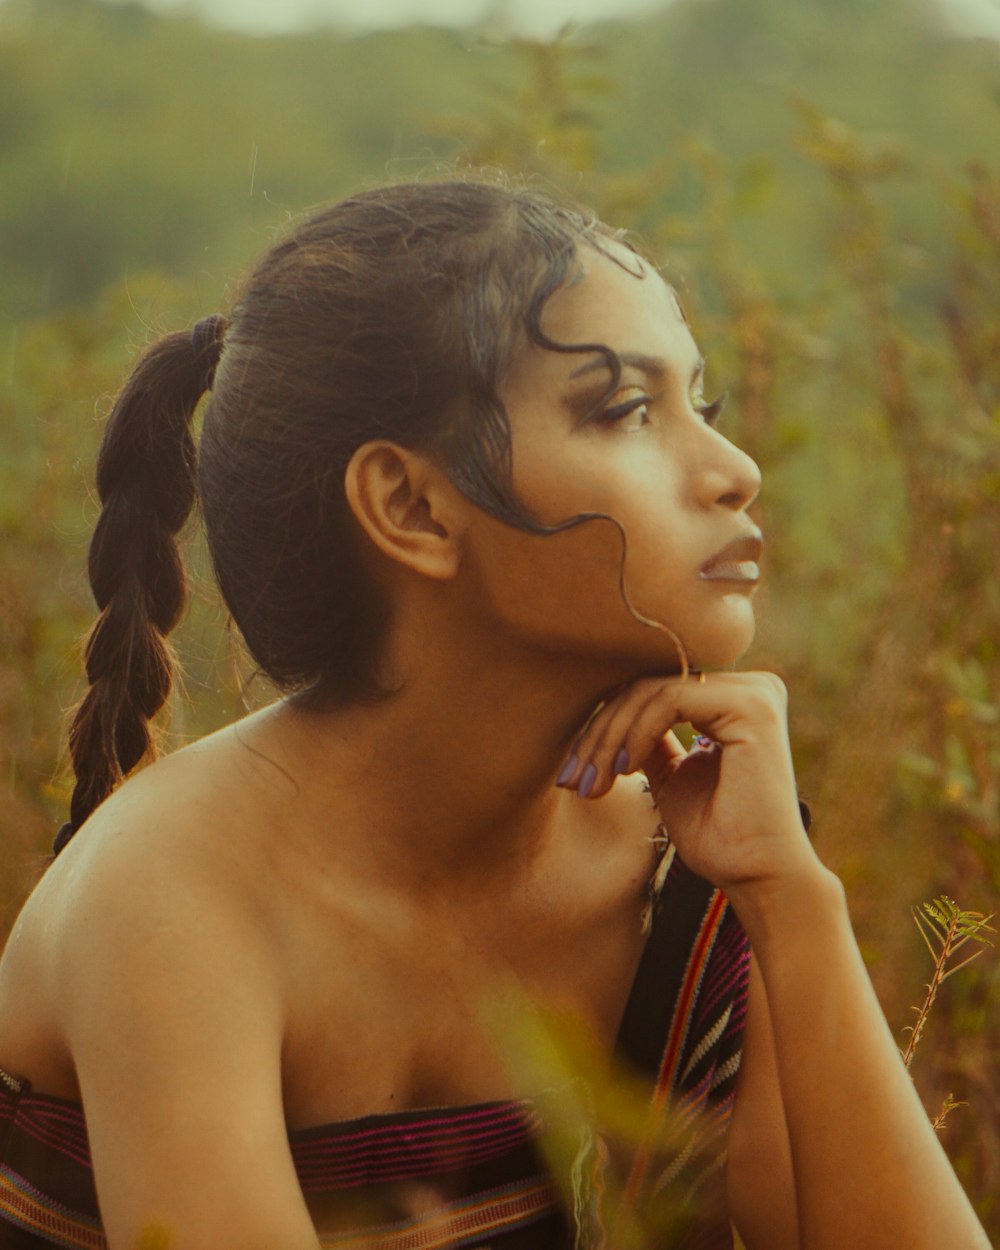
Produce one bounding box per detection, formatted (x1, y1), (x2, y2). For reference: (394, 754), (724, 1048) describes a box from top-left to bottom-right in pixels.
(509, 245), (700, 383)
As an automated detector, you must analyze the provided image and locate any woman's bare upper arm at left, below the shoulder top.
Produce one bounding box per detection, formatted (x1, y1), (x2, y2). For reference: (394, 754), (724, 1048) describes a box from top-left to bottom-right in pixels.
(54, 830), (318, 1250)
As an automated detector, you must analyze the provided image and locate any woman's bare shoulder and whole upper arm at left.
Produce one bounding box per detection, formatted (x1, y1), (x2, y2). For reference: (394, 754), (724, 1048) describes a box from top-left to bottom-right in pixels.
(0, 741), (325, 1250)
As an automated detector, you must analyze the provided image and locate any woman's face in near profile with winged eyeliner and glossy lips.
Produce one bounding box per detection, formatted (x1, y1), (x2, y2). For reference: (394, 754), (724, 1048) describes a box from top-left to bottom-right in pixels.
(460, 248), (760, 671)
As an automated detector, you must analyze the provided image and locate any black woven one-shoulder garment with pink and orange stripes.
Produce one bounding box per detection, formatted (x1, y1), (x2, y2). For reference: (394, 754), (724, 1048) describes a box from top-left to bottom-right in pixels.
(0, 848), (749, 1250)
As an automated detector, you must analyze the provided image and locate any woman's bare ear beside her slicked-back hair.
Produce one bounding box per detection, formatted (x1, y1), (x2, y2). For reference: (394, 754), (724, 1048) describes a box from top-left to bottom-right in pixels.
(344, 441), (463, 581)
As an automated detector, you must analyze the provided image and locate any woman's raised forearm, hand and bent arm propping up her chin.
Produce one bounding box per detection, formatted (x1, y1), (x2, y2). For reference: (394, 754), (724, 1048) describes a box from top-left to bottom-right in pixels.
(559, 673), (989, 1250)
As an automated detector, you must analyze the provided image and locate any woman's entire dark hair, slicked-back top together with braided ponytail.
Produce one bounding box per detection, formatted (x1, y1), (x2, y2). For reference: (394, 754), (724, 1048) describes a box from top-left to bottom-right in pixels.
(60, 179), (640, 845)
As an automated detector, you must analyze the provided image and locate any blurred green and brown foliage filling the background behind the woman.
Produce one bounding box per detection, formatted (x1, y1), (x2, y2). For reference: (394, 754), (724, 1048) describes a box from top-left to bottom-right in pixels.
(0, 0), (1000, 1240)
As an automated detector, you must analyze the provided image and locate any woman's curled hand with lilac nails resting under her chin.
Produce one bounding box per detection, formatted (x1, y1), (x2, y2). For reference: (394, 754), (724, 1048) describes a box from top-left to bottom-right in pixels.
(559, 673), (819, 894)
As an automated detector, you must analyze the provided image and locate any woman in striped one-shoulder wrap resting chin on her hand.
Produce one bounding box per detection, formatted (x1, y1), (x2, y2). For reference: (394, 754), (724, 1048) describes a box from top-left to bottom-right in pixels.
(0, 181), (986, 1250)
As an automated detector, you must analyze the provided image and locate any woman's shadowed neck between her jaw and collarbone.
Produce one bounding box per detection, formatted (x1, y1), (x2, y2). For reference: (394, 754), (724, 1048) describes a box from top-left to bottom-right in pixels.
(263, 615), (621, 886)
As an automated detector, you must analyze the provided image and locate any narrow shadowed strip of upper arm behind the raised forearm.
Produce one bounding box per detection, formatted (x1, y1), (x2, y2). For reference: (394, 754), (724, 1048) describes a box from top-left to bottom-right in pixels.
(726, 960), (799, 1250)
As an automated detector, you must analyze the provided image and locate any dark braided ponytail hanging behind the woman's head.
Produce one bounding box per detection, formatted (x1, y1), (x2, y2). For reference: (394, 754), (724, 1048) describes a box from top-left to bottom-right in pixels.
(54, 316), (226, 854)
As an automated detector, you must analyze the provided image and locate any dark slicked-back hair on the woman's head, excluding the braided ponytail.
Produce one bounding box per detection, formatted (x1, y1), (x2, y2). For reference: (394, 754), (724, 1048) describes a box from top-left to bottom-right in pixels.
(199, 178), (632, 706)
